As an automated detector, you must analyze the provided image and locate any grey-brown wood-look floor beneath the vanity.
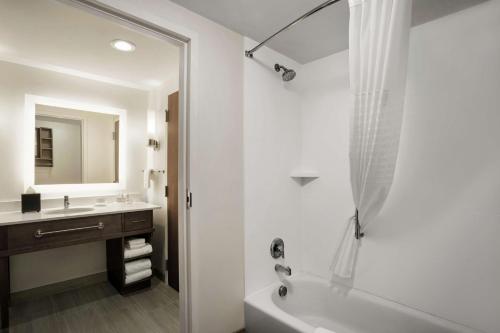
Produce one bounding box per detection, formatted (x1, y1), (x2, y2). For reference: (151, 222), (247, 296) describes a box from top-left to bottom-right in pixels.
(2, 279), (179, 333)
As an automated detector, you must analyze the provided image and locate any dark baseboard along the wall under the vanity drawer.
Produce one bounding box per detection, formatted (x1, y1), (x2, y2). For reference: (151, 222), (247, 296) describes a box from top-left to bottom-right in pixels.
(10, 272), (108, 304)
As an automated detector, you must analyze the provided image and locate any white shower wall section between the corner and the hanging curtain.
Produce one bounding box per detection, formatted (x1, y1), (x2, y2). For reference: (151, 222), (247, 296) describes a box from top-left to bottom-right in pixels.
(297, 51), (354, 278)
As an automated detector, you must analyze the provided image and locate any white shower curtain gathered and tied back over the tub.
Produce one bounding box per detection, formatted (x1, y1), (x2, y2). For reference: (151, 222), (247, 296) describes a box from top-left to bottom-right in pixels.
(332, 0), (412, 279)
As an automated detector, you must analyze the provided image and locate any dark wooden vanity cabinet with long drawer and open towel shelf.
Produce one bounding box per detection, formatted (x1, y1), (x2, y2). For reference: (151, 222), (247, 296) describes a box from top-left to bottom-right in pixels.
(0, 210), (154, 328)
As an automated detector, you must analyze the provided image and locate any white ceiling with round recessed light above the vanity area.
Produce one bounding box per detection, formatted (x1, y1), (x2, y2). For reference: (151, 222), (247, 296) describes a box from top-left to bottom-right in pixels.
(0, 0), (179, 89)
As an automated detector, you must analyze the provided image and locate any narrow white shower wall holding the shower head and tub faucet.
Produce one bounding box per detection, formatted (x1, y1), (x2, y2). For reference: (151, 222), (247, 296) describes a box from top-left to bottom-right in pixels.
(243, 38), (301, 295)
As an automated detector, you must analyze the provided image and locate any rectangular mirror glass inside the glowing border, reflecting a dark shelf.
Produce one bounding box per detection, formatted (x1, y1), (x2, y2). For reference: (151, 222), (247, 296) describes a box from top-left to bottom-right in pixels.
(35, 104), (120, 185)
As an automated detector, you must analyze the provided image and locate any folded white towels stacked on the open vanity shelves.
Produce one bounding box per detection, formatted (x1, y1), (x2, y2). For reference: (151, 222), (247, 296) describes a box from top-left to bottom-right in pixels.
(124, 238), (153, 284)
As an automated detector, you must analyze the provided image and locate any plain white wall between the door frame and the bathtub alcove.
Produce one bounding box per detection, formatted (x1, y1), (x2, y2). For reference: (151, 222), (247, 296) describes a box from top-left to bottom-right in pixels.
(96, 0), (244, 333)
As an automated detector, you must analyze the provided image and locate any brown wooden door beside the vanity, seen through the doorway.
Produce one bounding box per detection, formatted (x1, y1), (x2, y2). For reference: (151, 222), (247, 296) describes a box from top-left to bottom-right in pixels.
(167, 92), (179, 291)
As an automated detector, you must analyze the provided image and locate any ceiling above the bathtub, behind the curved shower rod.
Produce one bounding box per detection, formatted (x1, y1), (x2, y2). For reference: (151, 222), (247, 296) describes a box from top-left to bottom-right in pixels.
(172, 0), (486, 63)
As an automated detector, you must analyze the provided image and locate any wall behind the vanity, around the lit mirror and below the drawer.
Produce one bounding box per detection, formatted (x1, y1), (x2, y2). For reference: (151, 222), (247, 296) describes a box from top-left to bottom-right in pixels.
(0, 62), (148, 291)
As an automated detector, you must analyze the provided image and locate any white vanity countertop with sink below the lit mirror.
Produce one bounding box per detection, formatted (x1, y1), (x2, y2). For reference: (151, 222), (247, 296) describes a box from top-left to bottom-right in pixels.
(0, 202), (161, 227)
